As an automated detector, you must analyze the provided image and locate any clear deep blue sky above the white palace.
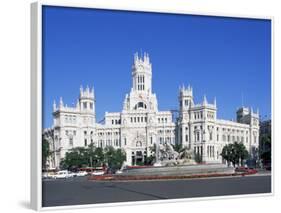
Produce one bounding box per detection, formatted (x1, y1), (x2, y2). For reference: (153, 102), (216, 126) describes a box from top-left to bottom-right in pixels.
(43, 7), (271, 128)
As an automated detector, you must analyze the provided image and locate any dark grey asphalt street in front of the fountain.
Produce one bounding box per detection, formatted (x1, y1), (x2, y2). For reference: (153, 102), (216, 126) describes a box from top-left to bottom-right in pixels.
(43, 175), (271, 207)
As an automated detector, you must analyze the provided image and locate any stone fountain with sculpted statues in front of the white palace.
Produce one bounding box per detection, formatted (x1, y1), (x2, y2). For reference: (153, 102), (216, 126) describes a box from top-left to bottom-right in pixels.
(118, 143), (234, 178)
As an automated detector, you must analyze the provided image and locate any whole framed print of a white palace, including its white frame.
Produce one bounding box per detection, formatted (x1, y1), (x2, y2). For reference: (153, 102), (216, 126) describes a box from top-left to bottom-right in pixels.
(31, 2), (273, 210)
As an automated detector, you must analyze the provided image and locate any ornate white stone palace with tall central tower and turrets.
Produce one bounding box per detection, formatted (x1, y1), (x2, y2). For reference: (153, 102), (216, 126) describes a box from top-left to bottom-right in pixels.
(43, 54), (259, 168)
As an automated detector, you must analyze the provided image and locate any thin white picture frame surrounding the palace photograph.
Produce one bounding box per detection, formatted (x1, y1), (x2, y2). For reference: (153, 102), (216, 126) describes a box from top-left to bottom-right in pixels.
(31, 1), (274, 210)
